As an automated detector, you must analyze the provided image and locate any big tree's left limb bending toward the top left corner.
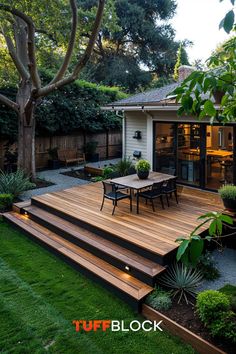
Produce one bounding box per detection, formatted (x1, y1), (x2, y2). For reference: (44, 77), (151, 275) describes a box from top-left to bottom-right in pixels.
(0, 4), (41, 89)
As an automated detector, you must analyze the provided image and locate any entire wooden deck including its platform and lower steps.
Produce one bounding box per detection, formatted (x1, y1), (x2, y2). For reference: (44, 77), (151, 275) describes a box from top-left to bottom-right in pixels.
(4, 183), (222, 310)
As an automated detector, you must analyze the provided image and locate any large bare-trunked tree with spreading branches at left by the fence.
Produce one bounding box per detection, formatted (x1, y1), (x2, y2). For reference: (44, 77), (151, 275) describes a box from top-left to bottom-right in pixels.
(0, 0), (105, 179)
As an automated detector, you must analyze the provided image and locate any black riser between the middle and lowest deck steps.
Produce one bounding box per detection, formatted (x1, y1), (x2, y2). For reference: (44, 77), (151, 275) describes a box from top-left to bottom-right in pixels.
(27, 210), (155, 286)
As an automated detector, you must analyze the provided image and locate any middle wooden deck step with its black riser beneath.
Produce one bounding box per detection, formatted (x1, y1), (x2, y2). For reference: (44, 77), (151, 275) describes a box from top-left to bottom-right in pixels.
(23, 205), (165, 286)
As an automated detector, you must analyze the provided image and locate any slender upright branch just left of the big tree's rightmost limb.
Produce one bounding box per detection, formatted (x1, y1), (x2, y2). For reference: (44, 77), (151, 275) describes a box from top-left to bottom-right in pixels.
(50, 0), (78, 84)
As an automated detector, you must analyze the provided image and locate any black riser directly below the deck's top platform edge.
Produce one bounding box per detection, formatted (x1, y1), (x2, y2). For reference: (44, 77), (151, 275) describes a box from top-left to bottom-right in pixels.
(32, 199), (166, 265)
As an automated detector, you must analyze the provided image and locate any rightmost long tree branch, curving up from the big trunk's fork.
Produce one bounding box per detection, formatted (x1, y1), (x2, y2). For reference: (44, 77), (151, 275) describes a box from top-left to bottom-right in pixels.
(35, 0), (105, 98)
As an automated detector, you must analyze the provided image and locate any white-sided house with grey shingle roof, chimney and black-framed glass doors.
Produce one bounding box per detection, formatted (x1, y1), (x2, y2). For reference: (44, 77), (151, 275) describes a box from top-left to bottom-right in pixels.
(103, 66), (236, 190)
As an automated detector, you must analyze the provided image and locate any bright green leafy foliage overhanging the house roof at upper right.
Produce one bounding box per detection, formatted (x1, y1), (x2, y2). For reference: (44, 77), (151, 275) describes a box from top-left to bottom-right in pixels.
(174, 0), (236, 123)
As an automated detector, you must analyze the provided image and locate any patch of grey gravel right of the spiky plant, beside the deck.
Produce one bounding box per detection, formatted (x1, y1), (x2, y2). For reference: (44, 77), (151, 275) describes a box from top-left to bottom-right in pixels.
(198, 248), (236, 291)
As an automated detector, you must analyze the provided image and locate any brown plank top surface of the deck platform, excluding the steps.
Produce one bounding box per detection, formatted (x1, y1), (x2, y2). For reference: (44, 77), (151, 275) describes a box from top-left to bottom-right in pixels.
(32, 183), (223, 257)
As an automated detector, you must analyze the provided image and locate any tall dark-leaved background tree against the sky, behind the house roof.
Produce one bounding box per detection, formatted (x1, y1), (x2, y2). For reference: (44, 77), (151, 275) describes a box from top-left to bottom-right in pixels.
(78, 0), (188, 92)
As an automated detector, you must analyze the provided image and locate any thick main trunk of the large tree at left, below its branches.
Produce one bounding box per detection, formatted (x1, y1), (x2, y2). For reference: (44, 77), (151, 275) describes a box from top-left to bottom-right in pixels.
(17, 82), (36, 180)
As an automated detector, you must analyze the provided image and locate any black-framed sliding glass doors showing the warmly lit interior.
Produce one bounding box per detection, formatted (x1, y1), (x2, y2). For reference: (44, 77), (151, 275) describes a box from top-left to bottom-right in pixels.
(153, 122), (236, 190)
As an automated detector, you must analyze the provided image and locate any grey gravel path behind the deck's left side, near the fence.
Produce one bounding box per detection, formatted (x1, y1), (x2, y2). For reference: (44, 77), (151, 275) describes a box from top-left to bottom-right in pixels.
(20, 159), (120, 200)
